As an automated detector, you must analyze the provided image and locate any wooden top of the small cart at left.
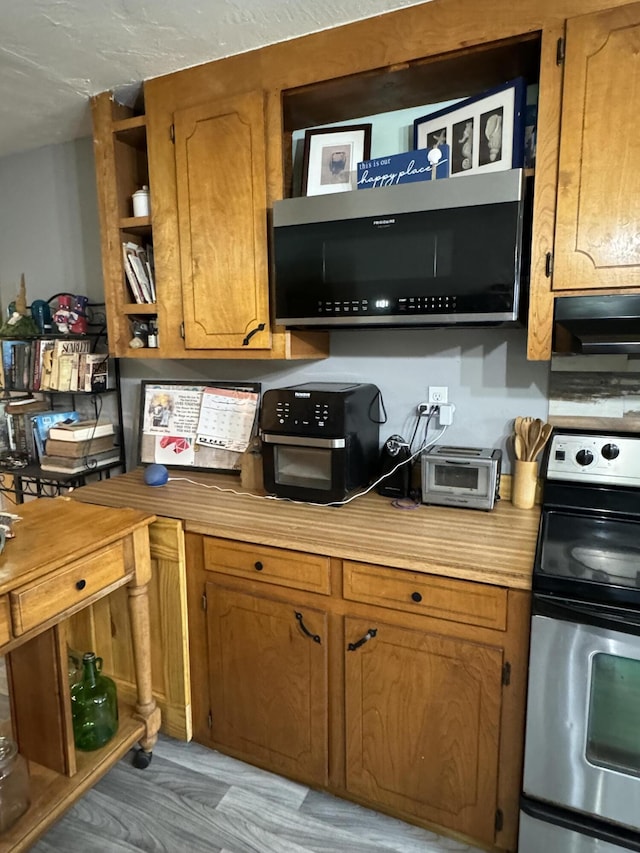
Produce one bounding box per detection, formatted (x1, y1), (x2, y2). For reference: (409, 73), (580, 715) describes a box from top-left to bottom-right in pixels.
(0, 497), (155, 593)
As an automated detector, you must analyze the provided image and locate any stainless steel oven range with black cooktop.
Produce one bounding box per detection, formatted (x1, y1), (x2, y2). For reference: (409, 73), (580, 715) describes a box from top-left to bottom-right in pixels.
(519, 430), (640, 853)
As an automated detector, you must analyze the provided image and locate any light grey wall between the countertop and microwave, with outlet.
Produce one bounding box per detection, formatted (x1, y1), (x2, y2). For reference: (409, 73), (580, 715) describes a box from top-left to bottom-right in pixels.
(117, 329), (548, 471)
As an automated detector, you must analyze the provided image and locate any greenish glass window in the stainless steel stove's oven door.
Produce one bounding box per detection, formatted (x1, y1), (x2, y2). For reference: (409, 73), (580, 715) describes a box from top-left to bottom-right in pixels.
(586, 652), (640, 776)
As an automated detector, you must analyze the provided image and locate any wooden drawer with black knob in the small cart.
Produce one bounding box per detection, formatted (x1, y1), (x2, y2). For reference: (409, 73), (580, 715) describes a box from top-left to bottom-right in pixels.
(10, 542), (127, 636)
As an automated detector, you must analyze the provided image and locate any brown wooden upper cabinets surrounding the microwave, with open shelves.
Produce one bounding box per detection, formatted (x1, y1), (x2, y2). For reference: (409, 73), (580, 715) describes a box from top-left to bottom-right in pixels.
(94, 0), (640, 360)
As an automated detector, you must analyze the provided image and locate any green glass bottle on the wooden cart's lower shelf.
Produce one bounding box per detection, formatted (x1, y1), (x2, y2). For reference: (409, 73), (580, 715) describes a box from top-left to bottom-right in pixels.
(71, 652), (118, 751)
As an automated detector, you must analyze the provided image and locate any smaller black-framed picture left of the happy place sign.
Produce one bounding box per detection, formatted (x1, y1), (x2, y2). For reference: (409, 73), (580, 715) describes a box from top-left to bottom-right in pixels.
(302, 124), (371, 195)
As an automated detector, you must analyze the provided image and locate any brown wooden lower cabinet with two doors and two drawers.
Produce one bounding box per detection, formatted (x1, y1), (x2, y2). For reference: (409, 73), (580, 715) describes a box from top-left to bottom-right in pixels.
(186, 533), (529, 850)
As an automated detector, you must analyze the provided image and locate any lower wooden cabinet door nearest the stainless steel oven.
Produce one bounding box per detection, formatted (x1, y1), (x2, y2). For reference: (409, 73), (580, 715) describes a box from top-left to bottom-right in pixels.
(345, 616), (503, 844)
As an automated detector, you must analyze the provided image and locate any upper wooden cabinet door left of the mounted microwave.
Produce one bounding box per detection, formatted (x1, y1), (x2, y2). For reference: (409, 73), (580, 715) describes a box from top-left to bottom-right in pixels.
(174, 93), (271, 349)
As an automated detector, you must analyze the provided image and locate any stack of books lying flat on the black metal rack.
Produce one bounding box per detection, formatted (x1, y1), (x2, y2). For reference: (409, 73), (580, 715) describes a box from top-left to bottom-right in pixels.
(40, 421), (120, 474)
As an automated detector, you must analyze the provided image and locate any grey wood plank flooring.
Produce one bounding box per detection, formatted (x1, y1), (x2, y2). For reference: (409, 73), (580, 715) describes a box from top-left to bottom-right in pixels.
(32, 736), (481, 853)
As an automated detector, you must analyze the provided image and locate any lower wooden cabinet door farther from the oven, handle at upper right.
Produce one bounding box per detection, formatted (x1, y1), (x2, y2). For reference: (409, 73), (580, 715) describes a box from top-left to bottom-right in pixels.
(206, 583), (328, 785)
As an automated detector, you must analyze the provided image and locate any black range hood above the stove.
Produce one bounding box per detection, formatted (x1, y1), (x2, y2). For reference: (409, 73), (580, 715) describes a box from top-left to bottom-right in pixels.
(553, 294), (640, 354)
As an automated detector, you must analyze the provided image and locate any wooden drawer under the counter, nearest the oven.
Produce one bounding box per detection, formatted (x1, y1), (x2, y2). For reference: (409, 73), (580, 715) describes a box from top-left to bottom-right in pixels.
(343, 560), (507, 631)
